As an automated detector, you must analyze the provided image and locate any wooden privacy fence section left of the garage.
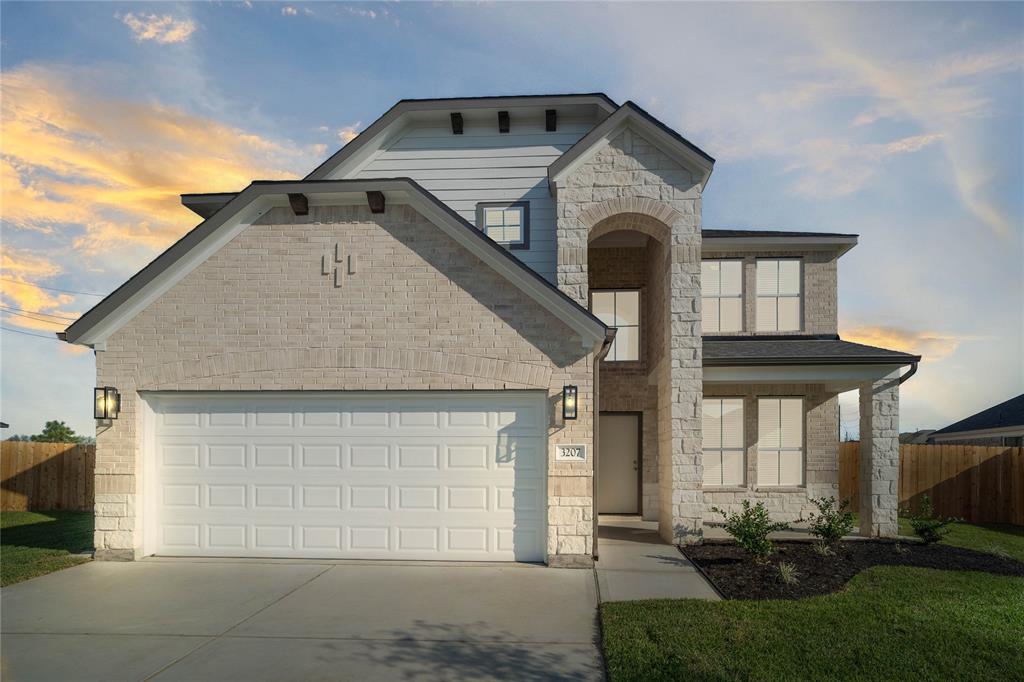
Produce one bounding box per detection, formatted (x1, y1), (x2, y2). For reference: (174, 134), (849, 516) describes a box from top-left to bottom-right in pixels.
(0, 440), (96, 511)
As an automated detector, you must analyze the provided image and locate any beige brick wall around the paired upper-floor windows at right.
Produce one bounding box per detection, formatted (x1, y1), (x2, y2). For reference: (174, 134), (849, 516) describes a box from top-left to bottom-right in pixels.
(703, 251), (839, 336)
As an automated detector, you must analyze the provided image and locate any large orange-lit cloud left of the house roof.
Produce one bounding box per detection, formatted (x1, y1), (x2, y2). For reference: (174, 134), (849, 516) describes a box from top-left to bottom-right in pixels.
(0, 66), (312, 260)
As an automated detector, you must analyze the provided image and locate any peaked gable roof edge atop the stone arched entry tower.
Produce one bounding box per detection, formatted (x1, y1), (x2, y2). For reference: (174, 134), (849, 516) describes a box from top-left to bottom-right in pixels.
(548, 101), (715, 193)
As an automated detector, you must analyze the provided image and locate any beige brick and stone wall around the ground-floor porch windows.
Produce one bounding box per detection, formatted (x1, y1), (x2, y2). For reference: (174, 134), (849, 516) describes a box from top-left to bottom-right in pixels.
(703, 384), (839, 522)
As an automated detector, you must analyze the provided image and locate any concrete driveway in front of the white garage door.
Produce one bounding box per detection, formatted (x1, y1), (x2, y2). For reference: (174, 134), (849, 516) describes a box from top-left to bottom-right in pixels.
(0, 559), (602, 682)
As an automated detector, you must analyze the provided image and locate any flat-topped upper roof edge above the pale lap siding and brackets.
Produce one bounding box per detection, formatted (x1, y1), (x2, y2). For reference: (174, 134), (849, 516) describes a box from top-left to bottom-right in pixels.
(305, 92), (617, 180)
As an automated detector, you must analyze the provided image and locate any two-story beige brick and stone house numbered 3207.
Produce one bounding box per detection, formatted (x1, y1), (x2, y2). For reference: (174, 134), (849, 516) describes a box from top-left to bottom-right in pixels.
(61, 94), (919, 566)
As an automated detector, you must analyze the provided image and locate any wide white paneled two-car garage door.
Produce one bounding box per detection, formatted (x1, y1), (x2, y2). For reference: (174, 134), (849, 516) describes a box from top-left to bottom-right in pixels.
(145, 391), (547, 561)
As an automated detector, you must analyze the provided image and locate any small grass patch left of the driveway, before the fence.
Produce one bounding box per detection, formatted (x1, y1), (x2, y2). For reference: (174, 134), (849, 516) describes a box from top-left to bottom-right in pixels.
(0, 511), (93, 586)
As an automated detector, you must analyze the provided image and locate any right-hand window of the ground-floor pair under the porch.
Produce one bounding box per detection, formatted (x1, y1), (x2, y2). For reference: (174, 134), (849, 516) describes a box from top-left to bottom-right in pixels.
(758, 398), (804, 486)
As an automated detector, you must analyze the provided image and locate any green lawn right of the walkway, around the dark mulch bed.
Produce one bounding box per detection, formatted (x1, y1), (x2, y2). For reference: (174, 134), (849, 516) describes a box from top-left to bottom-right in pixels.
(601, 524), (1024, 682)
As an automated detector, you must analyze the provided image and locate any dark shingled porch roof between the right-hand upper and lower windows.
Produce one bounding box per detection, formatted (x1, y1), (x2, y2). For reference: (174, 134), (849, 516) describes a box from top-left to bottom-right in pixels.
(703, 336), (921, 367)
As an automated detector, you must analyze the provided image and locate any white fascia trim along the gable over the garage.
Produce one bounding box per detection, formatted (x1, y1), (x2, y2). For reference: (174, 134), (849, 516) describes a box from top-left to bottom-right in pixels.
(74, 180), (605, 349)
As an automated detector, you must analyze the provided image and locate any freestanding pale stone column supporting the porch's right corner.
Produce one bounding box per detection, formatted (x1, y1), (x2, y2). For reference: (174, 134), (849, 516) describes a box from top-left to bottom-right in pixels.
(858, 372), (899, 538)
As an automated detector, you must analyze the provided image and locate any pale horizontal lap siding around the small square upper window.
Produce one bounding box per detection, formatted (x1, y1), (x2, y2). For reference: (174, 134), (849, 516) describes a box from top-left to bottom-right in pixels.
(349, 115), (594, 282)
